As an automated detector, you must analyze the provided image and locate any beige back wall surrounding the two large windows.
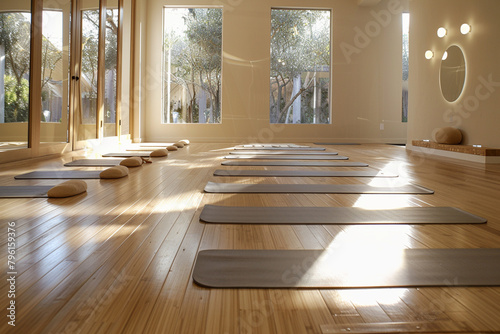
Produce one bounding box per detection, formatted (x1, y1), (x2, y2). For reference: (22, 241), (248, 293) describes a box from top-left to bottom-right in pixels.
(143, 0), (406, 143)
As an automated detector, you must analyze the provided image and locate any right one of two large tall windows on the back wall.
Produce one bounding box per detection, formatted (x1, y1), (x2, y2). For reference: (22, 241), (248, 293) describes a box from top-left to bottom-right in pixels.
(270, 9), (331, 124)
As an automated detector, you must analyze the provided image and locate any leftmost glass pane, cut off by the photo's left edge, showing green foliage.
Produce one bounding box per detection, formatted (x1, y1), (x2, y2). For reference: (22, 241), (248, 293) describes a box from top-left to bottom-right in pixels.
(0, 7), (31, 151)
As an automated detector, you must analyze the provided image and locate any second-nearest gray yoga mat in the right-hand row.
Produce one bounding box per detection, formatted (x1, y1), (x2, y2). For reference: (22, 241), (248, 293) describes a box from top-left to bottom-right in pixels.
(200, 205), (486, 225)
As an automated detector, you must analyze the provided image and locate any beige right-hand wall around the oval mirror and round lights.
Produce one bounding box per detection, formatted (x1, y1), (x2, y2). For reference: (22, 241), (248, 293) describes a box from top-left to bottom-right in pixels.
(408, 0), (500, 147)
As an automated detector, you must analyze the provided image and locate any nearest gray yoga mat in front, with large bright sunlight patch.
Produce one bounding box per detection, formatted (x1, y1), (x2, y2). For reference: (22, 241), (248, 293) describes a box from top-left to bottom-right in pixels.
(193, 248), (500, 289)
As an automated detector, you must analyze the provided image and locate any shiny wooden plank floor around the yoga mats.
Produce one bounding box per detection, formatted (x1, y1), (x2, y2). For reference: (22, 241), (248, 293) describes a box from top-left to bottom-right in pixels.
(0, 143), (500, 334)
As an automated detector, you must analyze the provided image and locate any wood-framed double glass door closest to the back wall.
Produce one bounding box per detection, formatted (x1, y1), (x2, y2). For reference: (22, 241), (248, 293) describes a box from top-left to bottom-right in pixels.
(75, 0), (120, 147)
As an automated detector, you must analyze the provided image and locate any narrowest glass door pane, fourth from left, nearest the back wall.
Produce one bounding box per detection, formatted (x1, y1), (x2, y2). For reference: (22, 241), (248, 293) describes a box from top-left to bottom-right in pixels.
(103, 1), (118, 137)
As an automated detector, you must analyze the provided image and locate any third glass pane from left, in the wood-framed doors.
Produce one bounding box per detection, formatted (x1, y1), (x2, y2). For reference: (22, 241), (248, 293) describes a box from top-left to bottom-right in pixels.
(78, 9), (99, 140)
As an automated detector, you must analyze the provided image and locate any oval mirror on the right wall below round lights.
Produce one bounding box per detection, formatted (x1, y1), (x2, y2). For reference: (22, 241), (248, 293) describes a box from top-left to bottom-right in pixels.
(439, 45), (466, 102)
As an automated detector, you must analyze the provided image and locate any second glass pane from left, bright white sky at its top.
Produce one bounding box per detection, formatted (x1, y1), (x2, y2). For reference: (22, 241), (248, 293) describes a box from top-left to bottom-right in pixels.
(40, 0), (71, 142)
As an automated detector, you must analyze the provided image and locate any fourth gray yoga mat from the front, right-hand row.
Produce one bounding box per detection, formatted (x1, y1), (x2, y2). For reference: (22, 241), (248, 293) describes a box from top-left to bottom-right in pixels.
(214, 169), (397, 177)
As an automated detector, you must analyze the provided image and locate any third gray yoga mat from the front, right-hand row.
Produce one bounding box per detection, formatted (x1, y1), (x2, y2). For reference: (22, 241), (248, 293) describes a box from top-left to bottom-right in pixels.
(205, 182), (434, 195)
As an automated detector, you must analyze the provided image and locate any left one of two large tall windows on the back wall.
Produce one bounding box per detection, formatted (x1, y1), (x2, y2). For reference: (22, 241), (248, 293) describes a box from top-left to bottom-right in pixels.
(162, 8), (222, 123)
